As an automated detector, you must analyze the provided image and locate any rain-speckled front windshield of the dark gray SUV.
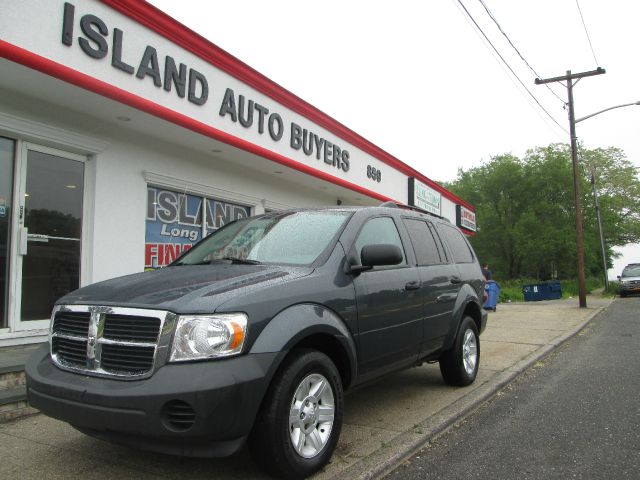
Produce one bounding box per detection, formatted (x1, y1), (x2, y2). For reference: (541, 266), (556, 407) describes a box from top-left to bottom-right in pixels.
(174, 211), (349, 265)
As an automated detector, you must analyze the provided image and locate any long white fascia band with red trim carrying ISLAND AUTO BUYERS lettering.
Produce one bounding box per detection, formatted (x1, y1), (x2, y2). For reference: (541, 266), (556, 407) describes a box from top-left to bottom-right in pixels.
(0, 0), (420, 199)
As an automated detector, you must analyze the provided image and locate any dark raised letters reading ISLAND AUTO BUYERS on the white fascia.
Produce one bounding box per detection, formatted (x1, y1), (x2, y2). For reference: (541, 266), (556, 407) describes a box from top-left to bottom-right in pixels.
(59, 2), (351, 173)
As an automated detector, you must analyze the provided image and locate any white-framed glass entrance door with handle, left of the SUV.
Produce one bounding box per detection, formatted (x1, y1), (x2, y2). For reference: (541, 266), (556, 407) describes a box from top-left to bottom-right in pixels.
(15, 145), (84, 330)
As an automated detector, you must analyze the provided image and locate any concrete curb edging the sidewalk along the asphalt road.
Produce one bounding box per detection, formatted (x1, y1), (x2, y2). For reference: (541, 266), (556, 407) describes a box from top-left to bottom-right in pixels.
(331, 304), (610, 480)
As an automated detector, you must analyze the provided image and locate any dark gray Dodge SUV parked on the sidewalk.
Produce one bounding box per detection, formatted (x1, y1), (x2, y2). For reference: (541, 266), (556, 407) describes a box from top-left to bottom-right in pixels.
(26, 204), (487, 478)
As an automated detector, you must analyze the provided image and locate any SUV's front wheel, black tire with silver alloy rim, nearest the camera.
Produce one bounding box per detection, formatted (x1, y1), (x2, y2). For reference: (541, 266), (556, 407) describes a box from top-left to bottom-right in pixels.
(249, 350), (344, 479)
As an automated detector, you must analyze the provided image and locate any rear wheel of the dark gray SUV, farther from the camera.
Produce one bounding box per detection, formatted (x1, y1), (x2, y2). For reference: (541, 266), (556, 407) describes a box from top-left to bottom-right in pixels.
(440, 317), (480, 387)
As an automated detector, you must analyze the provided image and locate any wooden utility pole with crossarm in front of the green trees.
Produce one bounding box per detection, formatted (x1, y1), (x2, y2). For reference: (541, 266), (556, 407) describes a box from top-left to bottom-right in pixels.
(535, 67), (605, 308)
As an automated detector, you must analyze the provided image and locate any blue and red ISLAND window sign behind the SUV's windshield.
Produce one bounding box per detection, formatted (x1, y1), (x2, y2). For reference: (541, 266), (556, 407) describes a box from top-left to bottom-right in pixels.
(144, 187), (250, 270)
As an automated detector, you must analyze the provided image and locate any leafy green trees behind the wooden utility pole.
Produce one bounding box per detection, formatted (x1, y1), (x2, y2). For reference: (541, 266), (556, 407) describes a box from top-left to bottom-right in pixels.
(447, 144), (640, 280)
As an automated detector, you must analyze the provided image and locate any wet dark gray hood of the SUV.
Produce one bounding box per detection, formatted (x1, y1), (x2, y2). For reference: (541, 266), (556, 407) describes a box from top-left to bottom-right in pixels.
(56, 264), (313, 313)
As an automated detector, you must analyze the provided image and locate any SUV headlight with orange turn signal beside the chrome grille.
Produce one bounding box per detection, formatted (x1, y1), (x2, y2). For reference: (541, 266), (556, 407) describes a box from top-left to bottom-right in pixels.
(170, 313), (247, 362)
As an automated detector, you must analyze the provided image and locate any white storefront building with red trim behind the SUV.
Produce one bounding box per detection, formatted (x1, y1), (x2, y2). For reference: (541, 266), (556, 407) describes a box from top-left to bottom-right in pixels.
(0, 0), (475, 346)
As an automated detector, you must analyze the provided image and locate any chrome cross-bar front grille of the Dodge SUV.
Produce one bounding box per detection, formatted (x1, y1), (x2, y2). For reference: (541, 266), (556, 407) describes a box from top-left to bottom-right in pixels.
(51, 305), (175, 378)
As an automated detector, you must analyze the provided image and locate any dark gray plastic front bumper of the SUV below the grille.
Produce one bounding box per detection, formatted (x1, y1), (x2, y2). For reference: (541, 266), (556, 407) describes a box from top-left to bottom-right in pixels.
(25, 346), (284, 457)
